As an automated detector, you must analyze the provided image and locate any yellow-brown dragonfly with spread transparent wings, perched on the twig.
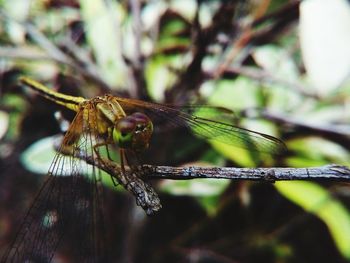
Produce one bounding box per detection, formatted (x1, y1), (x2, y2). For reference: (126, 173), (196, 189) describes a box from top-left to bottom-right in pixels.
(1, 77), (285, 262)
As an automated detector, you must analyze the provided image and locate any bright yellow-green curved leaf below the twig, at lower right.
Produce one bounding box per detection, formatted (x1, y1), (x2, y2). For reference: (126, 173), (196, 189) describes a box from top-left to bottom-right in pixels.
(275, 181), (350, 259)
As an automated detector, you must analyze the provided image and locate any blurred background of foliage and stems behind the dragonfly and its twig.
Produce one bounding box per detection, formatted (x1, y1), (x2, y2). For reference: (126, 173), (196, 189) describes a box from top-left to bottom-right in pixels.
(0, 0), (350, 262)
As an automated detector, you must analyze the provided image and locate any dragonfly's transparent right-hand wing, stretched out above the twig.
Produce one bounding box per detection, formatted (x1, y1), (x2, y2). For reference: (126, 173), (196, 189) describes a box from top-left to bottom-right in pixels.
(115, 97), (285, 154)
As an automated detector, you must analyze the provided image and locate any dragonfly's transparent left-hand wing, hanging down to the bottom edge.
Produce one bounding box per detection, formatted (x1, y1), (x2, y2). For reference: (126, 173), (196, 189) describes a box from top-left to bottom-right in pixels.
(1, 109), (108, 262)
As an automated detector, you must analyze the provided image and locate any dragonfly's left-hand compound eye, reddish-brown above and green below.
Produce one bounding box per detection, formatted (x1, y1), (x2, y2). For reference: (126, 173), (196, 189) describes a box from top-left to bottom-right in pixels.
(113, 116), (136, 148)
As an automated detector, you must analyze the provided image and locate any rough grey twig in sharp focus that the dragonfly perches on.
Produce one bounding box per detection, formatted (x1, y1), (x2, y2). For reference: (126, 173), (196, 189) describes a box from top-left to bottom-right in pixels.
(80, 154), (350, 215)
